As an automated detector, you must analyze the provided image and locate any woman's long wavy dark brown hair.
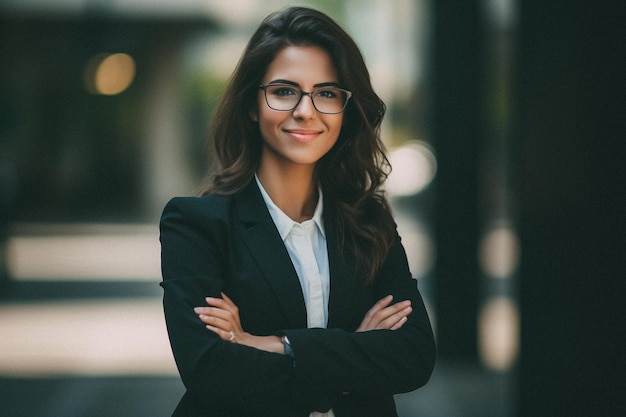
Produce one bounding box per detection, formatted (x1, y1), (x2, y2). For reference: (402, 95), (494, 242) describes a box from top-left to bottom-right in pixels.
(203, 7), (395, 282)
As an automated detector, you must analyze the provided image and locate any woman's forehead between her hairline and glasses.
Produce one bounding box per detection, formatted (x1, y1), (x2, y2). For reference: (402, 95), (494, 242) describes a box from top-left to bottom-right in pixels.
(262, 46), (338, 87)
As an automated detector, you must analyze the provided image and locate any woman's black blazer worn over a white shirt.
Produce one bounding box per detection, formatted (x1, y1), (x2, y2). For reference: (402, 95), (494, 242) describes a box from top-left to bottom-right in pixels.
(160, 181), (435, 417)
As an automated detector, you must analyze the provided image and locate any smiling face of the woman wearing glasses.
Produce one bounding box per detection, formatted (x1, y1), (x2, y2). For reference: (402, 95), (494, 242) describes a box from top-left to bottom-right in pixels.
(251, 46), (343, 170)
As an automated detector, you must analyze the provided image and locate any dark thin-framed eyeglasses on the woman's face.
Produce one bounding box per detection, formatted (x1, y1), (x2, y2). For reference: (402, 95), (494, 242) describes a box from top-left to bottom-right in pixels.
(259, 83), (352, 114)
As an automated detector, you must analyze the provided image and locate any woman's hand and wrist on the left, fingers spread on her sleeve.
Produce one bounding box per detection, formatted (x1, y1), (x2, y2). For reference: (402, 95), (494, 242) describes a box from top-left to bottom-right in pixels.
(194, 293), (285, 354)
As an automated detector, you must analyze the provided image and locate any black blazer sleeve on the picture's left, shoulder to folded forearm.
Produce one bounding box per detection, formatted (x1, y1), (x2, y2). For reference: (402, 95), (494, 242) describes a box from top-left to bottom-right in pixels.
(160, 196), (308, 416)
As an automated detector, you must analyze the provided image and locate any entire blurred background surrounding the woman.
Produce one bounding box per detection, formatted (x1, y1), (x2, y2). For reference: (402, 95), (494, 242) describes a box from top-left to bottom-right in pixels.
(0, 0), (626, 417)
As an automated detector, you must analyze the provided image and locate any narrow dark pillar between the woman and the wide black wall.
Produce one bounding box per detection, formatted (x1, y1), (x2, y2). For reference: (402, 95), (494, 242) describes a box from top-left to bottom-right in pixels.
(431, 1), (484, 361)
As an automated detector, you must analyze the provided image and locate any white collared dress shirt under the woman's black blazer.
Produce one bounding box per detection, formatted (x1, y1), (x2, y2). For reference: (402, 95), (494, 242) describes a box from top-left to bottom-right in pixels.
(255, 176), (335, 417)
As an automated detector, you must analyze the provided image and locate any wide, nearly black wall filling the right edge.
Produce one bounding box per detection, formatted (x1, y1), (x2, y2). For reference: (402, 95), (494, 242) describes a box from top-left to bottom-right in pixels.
(514, 0), (626, 417)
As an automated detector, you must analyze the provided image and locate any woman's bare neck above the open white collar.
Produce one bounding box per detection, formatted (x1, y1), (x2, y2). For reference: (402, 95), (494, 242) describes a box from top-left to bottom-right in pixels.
(257, 164), (318, 223)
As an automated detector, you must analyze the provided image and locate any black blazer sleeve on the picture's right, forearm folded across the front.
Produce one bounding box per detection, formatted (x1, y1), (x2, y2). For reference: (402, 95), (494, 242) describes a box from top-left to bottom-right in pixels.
(285, 231), (436, 407)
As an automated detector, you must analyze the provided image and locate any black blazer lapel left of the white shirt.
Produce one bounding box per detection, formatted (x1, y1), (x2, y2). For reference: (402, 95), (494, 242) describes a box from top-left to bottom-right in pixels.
(235, 181), (307, 329)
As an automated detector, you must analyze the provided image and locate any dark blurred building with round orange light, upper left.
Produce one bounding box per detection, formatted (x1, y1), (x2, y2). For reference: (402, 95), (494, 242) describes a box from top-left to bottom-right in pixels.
(0, 0), (217, 222)
